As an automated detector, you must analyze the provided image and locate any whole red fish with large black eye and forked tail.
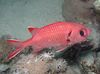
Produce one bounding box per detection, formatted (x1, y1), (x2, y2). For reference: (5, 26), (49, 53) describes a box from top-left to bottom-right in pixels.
(7, 22), (91, 60)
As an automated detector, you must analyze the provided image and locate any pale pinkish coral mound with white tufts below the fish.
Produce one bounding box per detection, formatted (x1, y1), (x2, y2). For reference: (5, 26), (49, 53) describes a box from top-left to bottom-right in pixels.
(10, 48), (67, 74)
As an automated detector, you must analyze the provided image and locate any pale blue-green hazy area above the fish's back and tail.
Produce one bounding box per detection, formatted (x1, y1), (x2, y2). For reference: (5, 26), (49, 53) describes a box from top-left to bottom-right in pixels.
(0, 0), (64, 40)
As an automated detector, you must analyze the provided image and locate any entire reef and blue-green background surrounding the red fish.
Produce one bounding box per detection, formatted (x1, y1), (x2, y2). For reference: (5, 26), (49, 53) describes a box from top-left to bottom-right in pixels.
(0, 0), (100, 74)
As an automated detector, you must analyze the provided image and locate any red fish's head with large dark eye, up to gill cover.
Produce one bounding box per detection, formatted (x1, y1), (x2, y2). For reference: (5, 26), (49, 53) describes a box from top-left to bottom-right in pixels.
(69, 23), (91, 44)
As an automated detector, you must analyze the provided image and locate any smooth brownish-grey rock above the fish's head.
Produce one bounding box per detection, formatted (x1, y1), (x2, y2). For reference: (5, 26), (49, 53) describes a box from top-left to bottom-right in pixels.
(62, 0), (95, 21)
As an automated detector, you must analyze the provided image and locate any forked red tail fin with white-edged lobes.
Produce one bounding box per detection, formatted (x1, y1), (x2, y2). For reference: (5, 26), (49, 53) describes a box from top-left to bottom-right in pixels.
(6, 39), (32, 61)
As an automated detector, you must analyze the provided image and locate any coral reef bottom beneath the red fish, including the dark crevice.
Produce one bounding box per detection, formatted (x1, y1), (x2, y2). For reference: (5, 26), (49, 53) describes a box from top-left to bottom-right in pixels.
(0, 35), (100, 74)
